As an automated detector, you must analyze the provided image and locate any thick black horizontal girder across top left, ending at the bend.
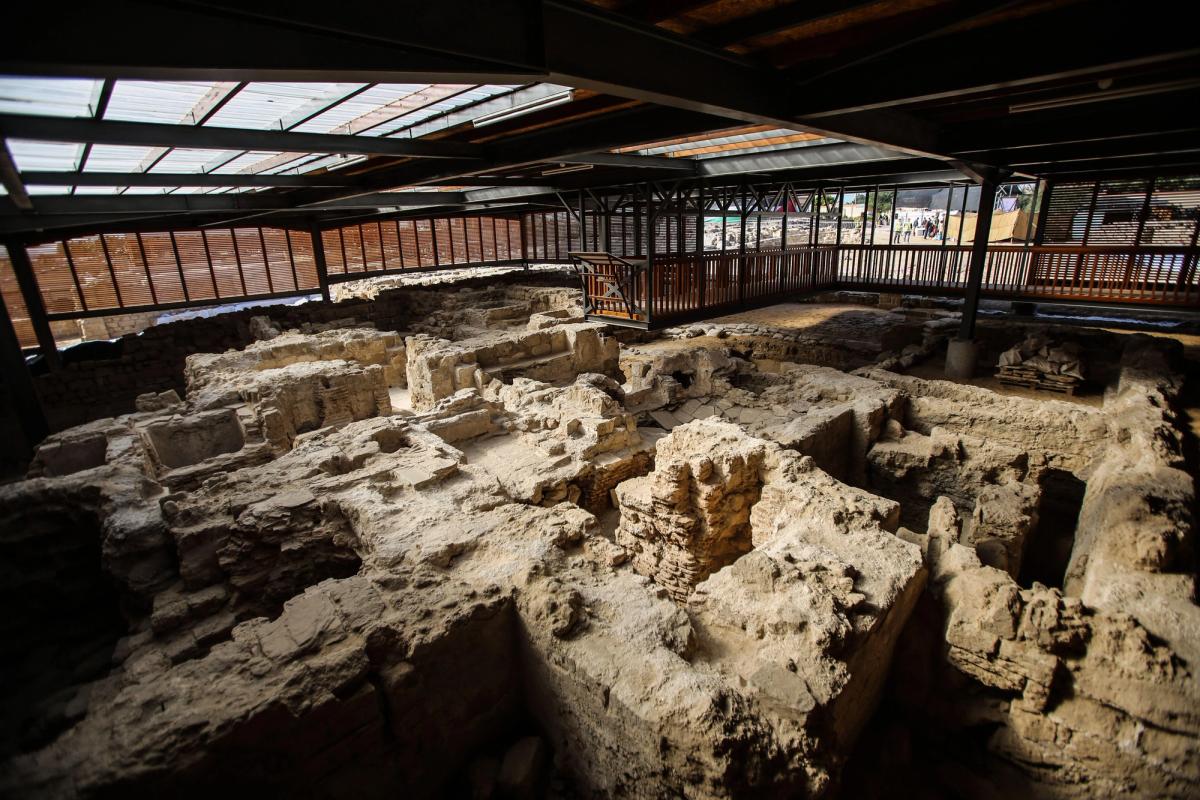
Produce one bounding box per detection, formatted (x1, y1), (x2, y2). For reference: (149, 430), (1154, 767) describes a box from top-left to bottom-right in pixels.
(0, 0), (542, 84)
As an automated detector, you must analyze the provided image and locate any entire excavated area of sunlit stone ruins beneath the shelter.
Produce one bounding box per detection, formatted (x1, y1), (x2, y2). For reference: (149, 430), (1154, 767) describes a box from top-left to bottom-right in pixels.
(0, 283), (1200, 799)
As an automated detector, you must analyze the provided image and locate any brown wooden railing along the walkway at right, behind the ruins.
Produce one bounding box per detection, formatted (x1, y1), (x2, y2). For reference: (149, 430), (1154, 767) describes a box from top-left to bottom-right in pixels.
(576, 245), (1200, 327)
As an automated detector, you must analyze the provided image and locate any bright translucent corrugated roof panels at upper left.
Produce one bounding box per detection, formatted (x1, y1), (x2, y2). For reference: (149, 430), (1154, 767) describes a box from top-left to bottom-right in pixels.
(0, 78), (556, 194)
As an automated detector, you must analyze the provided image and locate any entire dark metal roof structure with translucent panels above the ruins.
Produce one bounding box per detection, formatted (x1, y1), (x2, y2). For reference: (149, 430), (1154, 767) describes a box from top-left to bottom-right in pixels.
(0, 0), (1200, 239)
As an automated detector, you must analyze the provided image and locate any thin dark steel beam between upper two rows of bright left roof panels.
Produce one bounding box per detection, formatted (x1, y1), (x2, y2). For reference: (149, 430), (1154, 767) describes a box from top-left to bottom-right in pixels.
(0, 114), (485, 158)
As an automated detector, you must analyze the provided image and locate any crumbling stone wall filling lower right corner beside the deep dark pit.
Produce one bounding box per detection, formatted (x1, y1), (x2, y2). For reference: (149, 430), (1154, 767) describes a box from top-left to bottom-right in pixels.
(873, 337), (1200, 798)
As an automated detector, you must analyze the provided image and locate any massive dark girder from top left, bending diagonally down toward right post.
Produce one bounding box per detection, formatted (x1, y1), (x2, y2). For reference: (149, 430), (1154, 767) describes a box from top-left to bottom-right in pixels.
(0, 0), (940, 155)
